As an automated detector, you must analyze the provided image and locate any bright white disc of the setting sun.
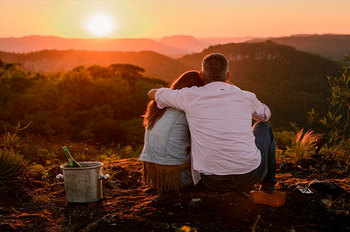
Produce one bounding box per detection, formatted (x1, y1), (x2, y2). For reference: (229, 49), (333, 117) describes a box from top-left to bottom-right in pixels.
(86, 14), (116, 37)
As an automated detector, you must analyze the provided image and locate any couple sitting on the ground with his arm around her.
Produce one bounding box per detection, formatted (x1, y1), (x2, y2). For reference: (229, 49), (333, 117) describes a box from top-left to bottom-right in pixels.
(139, 53), (286, 207)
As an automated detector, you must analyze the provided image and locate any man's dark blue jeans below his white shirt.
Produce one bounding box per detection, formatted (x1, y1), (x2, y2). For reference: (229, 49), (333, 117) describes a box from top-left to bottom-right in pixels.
(201, 122), (277, 192)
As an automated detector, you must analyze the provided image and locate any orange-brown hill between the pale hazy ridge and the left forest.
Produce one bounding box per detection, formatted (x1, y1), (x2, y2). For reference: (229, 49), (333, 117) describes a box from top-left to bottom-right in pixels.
(0, 50), (191, 81)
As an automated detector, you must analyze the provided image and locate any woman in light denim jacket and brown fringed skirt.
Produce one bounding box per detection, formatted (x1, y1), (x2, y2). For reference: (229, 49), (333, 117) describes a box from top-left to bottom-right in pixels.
(139, 71), (204, 191)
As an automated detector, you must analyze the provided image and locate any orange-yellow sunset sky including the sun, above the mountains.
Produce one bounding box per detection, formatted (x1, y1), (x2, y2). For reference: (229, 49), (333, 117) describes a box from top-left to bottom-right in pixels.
(0, 0), (350, 38)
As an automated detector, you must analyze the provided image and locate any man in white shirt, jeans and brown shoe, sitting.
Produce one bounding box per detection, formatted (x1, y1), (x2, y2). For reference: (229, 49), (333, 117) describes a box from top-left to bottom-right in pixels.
(148, 53), (285, 206)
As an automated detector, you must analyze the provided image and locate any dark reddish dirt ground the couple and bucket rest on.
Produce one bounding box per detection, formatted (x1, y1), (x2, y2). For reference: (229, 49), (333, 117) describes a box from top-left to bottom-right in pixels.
(0, 159), (350, 232)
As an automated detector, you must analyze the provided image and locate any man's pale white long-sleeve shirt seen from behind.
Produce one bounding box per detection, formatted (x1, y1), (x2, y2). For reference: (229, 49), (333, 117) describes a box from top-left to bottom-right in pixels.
(155, 81), (271, 184)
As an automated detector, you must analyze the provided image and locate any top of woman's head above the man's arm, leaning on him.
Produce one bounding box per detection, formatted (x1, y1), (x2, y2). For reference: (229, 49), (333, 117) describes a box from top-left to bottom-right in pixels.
(170, 71), (204, 89)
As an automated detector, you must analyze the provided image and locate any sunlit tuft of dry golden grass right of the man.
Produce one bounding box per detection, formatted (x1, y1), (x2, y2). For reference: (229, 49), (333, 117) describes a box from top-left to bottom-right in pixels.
(288, 129), (322, 162)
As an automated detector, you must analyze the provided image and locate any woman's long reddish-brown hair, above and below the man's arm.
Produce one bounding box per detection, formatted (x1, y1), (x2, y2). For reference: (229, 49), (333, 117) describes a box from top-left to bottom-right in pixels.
(143, 71), (204, 130)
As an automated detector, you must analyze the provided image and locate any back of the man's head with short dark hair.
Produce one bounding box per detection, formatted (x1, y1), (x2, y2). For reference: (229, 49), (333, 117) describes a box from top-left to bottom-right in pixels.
(202, 53), (228, 83)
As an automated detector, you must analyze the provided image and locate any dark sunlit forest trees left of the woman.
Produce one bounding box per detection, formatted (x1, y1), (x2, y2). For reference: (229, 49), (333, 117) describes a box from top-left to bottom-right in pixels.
(0, 61), (167, 145)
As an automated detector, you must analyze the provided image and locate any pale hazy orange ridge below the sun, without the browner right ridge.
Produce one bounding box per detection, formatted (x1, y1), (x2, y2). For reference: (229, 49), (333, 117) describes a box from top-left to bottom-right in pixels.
(0, 35), (252, 57)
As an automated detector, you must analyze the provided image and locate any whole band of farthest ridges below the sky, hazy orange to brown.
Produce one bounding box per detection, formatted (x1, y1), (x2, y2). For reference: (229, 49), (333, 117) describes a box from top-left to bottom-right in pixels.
(0, 34), (350, 60)
